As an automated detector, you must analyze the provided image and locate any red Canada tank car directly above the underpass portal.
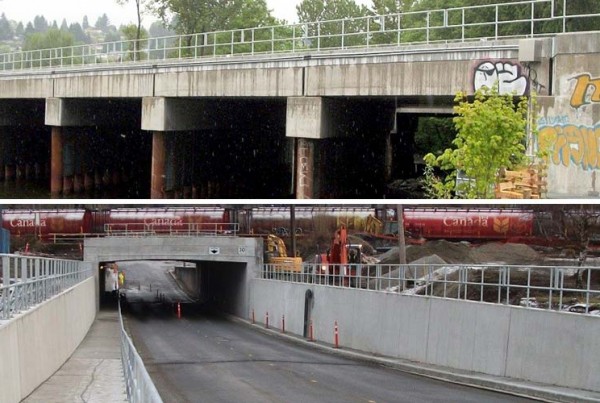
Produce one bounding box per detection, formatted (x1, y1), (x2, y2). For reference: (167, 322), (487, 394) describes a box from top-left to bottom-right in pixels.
(96, 207), (234, 233)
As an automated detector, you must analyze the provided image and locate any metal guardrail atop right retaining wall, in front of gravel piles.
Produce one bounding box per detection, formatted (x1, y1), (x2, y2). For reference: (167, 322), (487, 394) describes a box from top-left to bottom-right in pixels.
(261, 263), (600, 315)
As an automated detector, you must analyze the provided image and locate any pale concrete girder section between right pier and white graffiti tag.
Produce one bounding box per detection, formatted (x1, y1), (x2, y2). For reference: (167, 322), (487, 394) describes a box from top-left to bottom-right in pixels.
(305, 41), (518, 96)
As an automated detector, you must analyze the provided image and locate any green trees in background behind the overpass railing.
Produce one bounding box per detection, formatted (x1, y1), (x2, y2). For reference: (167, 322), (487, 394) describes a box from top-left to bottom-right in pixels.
(0, 0), (600, 52)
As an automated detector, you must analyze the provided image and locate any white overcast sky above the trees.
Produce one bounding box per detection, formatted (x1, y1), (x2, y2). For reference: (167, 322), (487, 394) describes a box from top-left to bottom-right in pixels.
(0, 0), (371, 26)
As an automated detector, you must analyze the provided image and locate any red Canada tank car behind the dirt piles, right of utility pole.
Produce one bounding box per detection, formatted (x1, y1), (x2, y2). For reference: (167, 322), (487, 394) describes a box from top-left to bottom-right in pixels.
(403, 208), (535, 240)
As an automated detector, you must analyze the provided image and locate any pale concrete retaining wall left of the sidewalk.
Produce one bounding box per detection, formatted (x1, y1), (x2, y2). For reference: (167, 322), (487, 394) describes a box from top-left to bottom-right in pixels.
(0, 278), (96, 403)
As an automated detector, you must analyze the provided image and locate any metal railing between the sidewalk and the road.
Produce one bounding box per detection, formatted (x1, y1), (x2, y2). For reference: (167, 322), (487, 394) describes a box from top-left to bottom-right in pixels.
(119, 303), (162, 403)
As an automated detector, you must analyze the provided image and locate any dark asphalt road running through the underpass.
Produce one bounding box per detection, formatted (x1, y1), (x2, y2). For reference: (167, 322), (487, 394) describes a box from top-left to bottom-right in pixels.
(126, 260), (531, 403)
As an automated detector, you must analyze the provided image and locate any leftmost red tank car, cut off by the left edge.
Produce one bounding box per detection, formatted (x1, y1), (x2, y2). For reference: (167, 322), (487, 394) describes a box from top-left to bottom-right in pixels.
(2, 209), (92, 238)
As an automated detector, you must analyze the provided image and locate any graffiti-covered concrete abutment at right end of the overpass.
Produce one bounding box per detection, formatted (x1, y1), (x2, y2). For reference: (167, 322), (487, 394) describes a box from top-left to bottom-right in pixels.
(538, 33), (600, 198)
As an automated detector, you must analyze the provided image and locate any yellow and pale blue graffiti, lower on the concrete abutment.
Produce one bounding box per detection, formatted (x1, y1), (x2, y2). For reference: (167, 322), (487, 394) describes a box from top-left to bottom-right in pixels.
(538, 116), (600, 170)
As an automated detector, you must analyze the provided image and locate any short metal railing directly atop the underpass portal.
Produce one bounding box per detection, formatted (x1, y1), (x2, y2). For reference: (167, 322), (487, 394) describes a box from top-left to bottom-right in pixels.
(104, 223), (239, 238)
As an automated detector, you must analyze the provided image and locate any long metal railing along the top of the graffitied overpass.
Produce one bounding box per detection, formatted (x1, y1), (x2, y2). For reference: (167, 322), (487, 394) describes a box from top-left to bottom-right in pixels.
(0, 0), (600, 72)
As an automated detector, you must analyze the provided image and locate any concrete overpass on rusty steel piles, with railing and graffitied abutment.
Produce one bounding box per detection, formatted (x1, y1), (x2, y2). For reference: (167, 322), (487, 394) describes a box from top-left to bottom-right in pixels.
(0, 0), (600, 199)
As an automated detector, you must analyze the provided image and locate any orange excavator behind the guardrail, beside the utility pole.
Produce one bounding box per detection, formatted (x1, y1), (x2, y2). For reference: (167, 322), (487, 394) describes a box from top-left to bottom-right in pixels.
(316, 225), (362, 287)
